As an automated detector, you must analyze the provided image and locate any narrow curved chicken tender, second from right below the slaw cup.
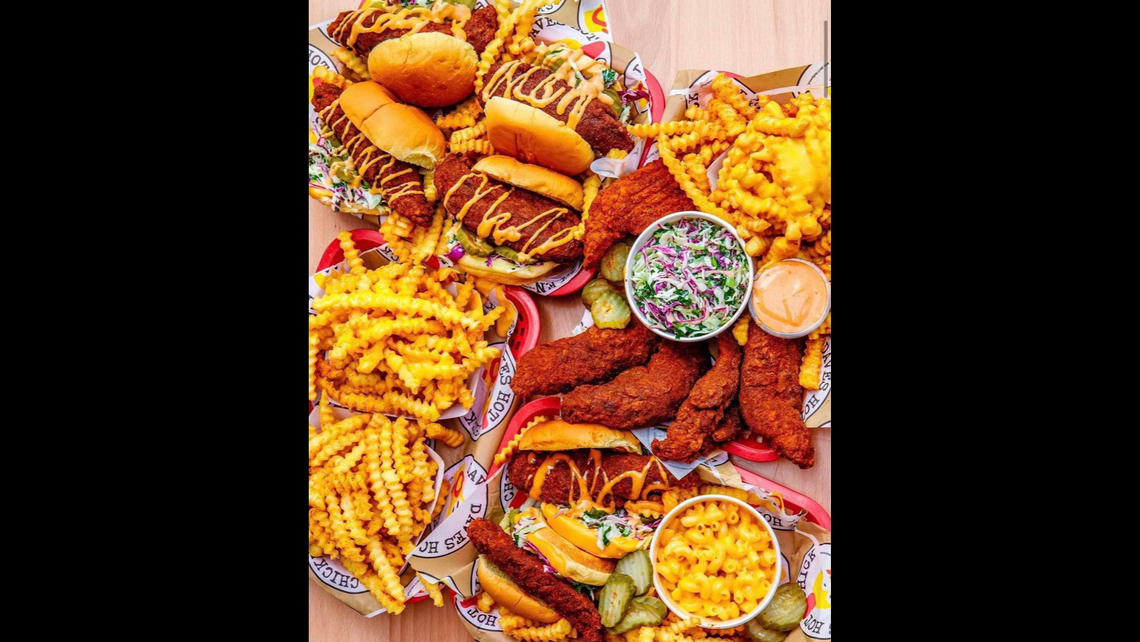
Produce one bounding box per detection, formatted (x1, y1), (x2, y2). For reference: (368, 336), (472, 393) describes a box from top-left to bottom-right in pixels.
(653, 332), (741, 461)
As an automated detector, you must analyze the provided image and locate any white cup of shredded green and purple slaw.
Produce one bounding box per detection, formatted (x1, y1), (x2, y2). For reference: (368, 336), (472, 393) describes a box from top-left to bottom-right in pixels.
(625, 211), (755, 343)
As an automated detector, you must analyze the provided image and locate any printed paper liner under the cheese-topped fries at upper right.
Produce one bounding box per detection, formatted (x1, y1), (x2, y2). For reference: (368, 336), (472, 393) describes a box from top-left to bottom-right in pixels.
(652, 62), (831, 428)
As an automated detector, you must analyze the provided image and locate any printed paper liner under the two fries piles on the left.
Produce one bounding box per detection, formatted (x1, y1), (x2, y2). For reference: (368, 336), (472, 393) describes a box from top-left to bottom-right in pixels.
(309, 245), (522, 617)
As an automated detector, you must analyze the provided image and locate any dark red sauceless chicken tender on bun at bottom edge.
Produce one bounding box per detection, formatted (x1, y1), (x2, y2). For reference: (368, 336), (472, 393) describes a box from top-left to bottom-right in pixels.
(467, 518), (602, 642)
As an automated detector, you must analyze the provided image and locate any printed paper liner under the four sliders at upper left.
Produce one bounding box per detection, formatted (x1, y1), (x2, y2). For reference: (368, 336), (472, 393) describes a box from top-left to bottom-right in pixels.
(309, 0), (651, 295)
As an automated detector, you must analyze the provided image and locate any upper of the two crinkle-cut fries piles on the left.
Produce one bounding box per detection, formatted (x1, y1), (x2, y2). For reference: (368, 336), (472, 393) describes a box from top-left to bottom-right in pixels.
(309, 218), (508, 424)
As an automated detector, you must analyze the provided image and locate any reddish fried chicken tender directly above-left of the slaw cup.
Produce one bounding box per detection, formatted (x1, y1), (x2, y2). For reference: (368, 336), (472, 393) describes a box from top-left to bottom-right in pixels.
(583, 159), (697, 268)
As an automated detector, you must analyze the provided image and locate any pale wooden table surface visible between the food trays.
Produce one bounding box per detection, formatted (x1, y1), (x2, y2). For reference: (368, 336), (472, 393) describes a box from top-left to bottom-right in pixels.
(308, 0), (831, 642)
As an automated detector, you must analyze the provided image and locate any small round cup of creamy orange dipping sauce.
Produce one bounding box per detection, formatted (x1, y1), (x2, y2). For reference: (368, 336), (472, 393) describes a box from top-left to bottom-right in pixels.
(752, 261), (828, 333)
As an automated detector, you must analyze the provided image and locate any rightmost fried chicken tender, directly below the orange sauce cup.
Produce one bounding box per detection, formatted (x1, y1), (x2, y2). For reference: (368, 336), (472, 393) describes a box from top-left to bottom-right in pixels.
(740, 320), (815, 469)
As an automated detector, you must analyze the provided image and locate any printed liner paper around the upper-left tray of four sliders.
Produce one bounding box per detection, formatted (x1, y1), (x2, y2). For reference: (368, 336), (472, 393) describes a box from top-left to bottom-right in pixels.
(309, 0), (665, 296)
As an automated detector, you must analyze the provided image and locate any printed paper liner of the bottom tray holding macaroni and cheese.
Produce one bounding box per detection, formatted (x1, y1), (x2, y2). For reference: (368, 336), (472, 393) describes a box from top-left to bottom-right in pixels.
(409, 453), (831, 642)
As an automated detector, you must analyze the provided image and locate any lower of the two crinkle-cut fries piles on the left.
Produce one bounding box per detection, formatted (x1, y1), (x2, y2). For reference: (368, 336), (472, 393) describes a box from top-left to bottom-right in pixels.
(309, 395), (456, 613)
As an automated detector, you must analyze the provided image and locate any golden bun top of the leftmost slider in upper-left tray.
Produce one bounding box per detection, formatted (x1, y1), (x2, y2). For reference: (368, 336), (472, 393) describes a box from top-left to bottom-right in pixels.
(340, 81), (447, 169)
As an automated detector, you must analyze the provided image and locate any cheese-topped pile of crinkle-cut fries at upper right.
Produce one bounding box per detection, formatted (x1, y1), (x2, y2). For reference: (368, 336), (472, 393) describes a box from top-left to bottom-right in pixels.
(628, 79), (831, 390)
